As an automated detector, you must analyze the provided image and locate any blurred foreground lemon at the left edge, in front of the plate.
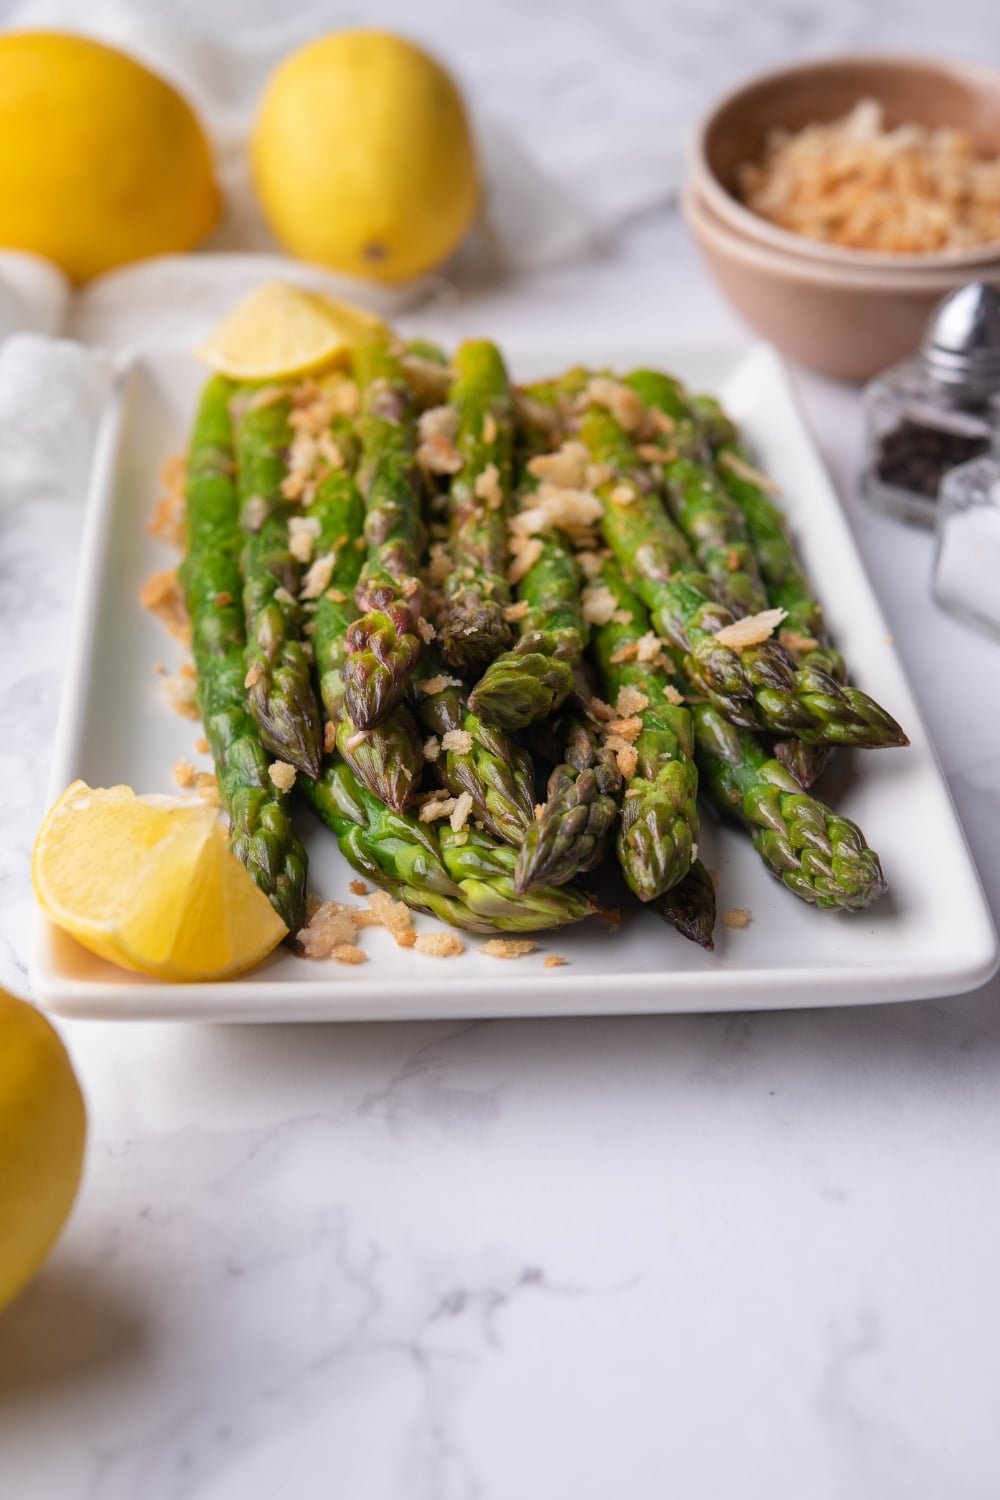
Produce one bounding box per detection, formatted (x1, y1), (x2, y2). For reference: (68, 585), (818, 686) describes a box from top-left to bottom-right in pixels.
(0, 990), (87, 1308)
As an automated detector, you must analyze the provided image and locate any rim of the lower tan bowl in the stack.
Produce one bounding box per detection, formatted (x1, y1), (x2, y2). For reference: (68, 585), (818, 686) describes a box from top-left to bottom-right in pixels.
(681, 179), (1000, 297)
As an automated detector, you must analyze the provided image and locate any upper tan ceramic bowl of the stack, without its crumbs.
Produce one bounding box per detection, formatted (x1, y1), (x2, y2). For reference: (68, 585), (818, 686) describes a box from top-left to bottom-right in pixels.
(688, 57), (1000, 279)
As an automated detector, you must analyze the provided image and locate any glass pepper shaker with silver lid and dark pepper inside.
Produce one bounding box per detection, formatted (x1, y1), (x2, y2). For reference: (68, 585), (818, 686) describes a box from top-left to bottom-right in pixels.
(861, 282), (1000, 527)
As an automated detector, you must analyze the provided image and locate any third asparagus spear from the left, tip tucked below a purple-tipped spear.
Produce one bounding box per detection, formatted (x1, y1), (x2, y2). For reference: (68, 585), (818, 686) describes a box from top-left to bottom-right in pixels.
(307, 444), (423, 813)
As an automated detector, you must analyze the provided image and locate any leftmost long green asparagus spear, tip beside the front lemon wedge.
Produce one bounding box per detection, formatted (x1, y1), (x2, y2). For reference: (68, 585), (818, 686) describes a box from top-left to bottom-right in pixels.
(181, 377), (306, 935)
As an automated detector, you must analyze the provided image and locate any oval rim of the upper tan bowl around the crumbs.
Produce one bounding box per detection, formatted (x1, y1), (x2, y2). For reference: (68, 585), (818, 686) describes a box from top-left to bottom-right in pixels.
(685, 53), (1000, 272)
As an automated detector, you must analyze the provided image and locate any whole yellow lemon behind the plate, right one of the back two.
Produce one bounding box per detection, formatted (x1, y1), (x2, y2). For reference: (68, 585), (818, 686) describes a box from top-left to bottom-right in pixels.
(253, 32), (480, 282)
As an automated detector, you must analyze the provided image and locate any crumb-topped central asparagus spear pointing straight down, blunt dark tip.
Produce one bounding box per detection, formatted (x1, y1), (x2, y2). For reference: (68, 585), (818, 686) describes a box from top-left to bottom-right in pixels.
(436, 342), (514, 677)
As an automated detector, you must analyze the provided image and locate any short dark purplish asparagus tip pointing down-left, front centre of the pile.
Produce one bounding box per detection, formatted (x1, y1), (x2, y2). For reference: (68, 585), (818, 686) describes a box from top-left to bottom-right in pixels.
(514, 719), (622, 893)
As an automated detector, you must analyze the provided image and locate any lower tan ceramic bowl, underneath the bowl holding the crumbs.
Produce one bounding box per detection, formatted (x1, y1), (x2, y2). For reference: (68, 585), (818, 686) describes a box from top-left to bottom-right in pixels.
(681, 176), (1000, 381)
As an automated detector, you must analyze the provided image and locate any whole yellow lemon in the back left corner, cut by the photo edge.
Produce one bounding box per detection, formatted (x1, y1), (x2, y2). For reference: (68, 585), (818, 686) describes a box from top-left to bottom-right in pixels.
(0, 32), (219, 282)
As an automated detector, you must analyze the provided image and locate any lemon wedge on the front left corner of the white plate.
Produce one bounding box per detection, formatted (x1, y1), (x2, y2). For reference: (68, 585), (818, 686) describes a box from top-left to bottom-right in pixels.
(31, 782), (286, 981)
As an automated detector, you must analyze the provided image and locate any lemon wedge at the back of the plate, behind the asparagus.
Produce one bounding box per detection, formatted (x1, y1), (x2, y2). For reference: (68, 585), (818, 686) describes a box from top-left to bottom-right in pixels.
(195, 282), (388, 380)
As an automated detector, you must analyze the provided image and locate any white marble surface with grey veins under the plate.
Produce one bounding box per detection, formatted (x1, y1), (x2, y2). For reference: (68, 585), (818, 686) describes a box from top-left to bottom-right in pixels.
(0, 0), (1000, 1500)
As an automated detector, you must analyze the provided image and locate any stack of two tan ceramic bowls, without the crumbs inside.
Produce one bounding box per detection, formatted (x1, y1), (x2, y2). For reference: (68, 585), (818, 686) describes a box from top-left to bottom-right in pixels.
(682, 56), (1000, 381)
